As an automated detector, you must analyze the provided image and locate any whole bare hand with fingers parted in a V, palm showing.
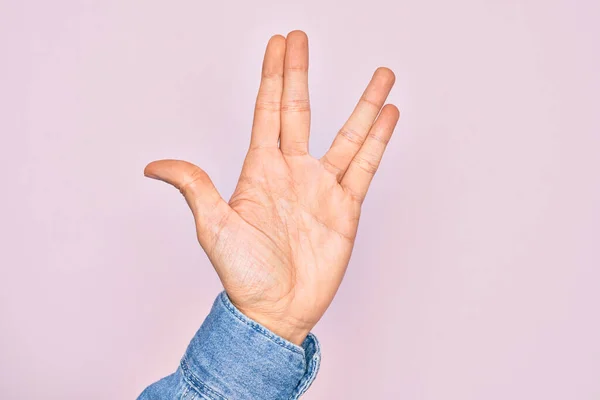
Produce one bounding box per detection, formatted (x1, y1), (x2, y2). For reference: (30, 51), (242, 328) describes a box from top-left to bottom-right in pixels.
(144, 31), (399, 345)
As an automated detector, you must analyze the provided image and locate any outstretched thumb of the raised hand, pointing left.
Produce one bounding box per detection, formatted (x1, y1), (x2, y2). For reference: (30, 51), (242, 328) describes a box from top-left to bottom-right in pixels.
(144, 160), (232, 251)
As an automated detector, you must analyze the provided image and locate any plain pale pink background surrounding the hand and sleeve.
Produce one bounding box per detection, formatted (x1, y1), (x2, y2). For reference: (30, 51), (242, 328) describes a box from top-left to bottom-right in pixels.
(0, 0), (600, 400)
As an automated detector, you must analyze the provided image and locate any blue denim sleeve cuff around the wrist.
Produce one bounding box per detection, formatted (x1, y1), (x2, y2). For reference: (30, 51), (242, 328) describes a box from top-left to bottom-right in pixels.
(138, 292), (321, 400)
